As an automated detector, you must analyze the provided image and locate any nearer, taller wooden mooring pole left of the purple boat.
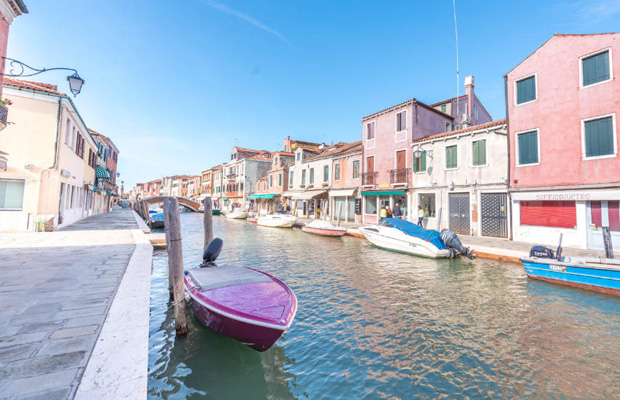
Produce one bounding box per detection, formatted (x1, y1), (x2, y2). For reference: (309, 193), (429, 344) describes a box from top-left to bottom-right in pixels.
(164, 198), (187, 335)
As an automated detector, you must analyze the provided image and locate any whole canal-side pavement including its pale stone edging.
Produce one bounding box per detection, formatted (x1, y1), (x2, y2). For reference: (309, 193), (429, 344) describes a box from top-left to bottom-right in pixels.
(0, 208), (152, 399)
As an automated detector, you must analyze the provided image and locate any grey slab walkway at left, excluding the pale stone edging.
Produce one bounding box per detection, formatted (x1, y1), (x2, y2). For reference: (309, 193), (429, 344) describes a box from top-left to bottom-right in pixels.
(0, 209), (147, 400)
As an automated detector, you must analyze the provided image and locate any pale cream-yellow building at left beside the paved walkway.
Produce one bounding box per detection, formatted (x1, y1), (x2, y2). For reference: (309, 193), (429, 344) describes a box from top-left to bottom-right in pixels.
(0, 77), (97, 231)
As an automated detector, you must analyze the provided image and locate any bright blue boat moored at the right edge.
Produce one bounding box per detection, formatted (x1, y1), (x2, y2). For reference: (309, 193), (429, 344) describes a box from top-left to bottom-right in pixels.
(521, 239), (620, 296)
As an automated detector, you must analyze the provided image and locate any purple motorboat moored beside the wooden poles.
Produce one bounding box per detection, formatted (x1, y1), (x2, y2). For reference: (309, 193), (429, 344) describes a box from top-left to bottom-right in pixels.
(185, 238), (297, 351)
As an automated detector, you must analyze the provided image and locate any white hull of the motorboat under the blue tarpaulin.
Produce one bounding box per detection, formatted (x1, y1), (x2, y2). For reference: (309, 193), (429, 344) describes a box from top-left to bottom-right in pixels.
(359, 226), (450, 258)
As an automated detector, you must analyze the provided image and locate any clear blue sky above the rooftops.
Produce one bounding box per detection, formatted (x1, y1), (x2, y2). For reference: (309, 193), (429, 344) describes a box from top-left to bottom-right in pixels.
(8, 0), (620, 189)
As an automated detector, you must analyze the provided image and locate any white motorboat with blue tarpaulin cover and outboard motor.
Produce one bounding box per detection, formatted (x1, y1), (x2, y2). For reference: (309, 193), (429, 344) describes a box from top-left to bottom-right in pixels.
(359, 218), (475, 258)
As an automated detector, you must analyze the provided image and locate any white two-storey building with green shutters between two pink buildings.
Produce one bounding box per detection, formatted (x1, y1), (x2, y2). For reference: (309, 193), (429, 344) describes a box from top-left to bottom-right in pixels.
(406, 120), (510, 238)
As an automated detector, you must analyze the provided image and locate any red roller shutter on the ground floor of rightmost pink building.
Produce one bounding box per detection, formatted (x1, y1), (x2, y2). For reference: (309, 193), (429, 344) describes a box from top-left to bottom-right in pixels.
(521, 201), (577, 229)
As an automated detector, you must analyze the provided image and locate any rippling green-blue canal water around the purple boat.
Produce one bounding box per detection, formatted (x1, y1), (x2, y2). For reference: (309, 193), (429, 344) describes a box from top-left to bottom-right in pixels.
(148, 213), (620, 400)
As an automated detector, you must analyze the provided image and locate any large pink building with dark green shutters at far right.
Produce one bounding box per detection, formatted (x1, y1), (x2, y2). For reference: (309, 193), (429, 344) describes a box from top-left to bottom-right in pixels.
(505, 33), (620, 249)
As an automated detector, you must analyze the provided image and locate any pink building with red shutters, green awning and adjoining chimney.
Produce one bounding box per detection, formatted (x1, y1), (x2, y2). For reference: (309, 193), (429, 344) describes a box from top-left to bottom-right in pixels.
(361, 76), (491, 223)
